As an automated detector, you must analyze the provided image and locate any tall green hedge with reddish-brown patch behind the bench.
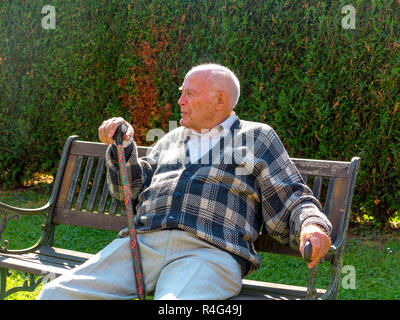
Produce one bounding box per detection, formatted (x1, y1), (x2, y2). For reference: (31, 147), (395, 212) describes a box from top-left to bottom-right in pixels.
(0, 0), (400, 223)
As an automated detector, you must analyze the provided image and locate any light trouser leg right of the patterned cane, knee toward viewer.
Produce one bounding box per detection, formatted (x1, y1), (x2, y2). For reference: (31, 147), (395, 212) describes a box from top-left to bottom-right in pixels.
(154, 231), (242, 300)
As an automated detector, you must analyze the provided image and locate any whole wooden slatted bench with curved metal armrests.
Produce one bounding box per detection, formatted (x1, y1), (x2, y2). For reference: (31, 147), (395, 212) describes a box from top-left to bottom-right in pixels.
(0, 136), (360, 299)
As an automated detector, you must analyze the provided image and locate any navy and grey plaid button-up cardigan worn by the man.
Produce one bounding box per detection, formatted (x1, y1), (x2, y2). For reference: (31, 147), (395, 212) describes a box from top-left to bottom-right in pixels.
(106, 119), (331, 273)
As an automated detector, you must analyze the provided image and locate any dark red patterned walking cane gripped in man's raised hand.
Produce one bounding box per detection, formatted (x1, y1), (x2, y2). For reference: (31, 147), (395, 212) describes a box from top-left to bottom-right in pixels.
(113, 123), (146, 300)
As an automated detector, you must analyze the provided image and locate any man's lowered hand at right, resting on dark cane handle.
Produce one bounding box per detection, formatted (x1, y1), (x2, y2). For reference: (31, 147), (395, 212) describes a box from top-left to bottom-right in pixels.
(300, 224), (332, 269)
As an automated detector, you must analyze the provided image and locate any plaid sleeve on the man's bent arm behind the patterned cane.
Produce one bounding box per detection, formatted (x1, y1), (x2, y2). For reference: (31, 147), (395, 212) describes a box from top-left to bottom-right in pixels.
(105, 139), (157, 202)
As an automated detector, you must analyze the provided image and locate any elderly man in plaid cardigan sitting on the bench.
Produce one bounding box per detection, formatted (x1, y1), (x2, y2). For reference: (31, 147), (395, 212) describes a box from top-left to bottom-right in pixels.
(39, 64), (331, 299)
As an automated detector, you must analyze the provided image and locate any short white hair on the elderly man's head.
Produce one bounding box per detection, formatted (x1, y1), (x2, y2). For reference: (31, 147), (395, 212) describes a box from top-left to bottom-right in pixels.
(185, 63), (240, 108)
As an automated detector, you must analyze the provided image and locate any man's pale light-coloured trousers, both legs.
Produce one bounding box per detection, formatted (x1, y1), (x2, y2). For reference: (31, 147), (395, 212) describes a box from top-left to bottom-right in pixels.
(38, 230), (242, 300)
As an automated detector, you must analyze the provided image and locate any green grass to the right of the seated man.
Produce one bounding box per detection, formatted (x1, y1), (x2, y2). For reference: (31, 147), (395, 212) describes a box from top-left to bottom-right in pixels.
(249, 236), (400, 300)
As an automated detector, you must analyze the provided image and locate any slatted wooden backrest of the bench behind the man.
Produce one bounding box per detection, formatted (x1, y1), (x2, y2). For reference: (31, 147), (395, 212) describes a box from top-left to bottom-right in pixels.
(50, 136), (360, 264)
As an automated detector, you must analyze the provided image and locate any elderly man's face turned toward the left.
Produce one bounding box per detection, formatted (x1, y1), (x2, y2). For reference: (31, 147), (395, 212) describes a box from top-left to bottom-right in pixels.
(178, 72), (217, 132)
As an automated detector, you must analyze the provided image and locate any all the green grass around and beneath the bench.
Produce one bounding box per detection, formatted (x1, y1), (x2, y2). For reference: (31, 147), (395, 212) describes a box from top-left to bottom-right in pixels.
(0, 189), (400, 300)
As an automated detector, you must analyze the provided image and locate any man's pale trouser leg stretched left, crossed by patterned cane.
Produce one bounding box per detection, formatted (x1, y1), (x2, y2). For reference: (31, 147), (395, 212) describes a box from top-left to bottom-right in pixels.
(38, 235), (163, 300)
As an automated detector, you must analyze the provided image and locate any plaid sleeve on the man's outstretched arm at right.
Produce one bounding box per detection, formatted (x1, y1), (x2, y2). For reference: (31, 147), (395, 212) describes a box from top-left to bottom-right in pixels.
(259, 128), (332, 250)
